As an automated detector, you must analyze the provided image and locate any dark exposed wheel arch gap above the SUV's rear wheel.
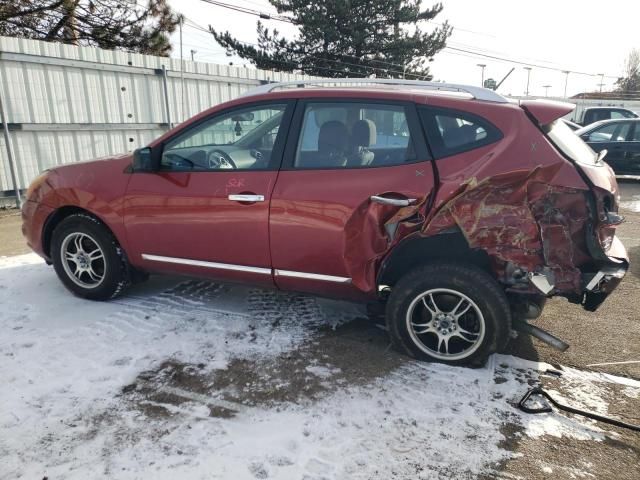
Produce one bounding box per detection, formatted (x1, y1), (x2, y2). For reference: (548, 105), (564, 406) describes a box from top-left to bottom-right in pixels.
(377, 228), (495, 286)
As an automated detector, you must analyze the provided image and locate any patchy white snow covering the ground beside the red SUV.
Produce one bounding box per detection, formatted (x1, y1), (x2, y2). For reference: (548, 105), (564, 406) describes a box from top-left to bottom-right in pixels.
(0, 255), (640, 480)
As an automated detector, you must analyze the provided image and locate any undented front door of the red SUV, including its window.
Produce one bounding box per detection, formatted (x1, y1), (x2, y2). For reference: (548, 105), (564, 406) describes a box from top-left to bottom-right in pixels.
(124, 102), (293, 285)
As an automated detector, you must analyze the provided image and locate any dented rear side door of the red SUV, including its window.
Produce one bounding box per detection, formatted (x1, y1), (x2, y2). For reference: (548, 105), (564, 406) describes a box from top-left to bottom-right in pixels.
(270, 99), (434, 296)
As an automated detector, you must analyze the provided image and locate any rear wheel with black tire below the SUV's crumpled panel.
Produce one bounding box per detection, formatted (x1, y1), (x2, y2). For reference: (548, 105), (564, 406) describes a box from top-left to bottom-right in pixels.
(386, 262), (511, 367)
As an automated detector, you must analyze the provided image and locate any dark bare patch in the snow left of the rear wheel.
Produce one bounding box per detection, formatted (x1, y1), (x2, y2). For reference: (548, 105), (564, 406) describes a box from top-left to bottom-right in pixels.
(122, 318), (410, 417)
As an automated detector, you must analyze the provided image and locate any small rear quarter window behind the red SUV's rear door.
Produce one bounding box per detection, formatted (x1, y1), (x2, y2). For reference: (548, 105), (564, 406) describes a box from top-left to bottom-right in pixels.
(420, 107), (502, 158)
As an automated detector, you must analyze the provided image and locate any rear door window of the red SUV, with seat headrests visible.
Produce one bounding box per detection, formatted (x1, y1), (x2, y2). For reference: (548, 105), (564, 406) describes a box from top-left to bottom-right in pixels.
(294, 102), (416, 168)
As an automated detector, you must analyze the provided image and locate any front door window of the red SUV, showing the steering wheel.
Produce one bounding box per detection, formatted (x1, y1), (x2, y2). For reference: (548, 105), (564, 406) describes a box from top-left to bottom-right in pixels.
(160, 105), (286, 171)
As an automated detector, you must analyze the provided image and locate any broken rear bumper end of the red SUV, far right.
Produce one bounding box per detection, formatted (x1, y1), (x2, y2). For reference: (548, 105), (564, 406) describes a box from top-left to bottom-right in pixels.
(582, 237), (629, 312)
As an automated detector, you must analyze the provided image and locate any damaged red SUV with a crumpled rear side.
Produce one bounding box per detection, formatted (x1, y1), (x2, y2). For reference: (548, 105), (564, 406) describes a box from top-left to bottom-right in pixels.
(23, 79), (628, 364)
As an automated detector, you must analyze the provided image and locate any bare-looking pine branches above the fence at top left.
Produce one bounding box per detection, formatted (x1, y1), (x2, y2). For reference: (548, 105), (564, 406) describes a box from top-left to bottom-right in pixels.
(0, 0), (180, 56)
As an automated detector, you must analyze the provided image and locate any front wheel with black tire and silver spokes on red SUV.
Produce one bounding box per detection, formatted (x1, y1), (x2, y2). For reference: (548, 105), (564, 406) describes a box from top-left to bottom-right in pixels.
(51, 213), (131, 300)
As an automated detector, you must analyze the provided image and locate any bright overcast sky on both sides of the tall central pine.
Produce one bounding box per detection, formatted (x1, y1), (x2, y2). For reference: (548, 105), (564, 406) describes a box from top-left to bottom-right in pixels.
(170, 0), (640, 96)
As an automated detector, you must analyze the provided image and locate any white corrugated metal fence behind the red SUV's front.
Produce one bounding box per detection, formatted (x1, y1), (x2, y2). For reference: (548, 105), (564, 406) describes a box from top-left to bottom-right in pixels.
(0, 37), (311, 195)
